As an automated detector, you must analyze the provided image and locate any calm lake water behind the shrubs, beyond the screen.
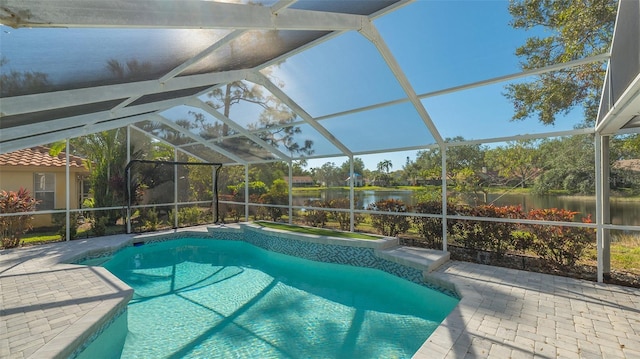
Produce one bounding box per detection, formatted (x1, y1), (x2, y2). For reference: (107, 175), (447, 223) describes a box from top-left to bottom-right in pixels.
(293, 189), (640, 226)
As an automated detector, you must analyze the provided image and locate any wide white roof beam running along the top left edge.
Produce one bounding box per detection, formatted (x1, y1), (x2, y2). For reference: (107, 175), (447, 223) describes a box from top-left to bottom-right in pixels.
(0, 0), (368, 31)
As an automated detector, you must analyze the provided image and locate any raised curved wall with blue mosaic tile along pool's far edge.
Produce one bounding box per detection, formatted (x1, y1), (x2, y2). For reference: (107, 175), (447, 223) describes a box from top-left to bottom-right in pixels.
(72, 222), (460, 298)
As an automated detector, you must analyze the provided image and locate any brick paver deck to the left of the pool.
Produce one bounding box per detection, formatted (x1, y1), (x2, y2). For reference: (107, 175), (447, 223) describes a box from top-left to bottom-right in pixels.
(0, 236), (133, 359)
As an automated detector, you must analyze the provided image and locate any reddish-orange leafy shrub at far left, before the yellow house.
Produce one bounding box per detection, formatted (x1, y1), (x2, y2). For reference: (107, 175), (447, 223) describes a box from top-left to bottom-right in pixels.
(0, 188), (38, 248)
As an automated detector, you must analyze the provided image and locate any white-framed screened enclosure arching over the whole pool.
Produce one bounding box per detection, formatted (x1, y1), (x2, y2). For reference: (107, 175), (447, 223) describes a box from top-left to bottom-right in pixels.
(0, 0), (640, 281)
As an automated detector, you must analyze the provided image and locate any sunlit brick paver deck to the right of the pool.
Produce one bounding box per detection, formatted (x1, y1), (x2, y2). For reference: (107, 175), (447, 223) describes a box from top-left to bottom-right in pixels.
(414, 262), (640, 359)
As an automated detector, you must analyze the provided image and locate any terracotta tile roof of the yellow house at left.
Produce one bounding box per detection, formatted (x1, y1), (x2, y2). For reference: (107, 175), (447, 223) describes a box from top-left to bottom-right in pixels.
(0, 146), (84, 168)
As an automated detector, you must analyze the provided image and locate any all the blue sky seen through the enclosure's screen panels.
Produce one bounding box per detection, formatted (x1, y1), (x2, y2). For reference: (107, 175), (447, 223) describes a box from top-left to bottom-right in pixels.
(0, 0), (596, 170)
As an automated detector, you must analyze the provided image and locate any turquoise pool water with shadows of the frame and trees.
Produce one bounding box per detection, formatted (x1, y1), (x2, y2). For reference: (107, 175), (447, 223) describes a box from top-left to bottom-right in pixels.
(80, 239), (458, 359)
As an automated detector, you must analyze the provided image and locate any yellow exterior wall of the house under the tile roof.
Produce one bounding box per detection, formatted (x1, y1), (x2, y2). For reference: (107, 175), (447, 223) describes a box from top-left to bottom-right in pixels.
(0, 166), (86, 228)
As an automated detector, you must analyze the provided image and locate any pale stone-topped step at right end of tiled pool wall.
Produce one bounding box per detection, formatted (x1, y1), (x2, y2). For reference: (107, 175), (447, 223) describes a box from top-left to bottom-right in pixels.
(375, 246), (450, 273)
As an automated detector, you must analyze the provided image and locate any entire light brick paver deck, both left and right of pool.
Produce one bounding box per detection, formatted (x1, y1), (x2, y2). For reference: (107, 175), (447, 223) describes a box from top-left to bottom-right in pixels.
(0, 228), (640, 359)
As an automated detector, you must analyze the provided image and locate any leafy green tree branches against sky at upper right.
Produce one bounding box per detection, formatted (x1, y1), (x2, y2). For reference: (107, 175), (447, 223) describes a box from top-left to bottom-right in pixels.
(505, 0), (616, 124)
